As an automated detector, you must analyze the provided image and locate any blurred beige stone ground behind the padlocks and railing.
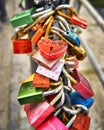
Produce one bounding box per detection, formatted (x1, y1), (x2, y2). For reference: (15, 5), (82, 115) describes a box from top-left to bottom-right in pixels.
(0, 0), (104, 130)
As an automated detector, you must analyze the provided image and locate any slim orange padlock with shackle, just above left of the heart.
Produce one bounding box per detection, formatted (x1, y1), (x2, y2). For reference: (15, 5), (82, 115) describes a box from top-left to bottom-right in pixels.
(31, 16), (53, 44)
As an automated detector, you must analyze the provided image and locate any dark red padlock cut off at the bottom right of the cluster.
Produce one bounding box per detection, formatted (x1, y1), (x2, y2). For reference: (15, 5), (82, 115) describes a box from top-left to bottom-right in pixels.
(69, 113), (90, 130)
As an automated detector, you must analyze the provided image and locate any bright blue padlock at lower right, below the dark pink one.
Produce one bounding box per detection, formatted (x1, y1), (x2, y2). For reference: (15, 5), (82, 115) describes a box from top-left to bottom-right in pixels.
(70, 91), (94, 108)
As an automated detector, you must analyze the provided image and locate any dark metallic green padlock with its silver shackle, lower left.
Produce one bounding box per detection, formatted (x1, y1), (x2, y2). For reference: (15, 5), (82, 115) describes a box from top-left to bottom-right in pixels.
(18, 82), (63, 105)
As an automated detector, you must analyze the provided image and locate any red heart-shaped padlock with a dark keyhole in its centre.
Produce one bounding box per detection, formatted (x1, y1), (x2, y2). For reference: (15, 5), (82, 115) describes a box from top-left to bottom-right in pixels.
(38, 38), (68, 59)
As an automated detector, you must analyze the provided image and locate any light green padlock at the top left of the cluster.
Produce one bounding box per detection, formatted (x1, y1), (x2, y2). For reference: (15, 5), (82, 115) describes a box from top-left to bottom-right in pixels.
(10, 8), (35, 27)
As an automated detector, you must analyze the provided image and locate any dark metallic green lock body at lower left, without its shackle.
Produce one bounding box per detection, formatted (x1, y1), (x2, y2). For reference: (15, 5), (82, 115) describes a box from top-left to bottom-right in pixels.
(18, 82), (44, 105)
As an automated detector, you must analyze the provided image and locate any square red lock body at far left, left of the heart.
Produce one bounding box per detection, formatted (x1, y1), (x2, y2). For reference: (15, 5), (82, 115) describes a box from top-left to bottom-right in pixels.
(13, 39), (32, 54)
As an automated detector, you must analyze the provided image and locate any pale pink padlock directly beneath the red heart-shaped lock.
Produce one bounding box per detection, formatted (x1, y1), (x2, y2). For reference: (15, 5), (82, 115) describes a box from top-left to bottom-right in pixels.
(32, 50), (60, 69)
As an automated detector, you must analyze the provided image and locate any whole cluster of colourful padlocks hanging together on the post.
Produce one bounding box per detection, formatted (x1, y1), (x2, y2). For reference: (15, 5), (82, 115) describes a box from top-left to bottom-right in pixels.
(10, 1), (94, 130)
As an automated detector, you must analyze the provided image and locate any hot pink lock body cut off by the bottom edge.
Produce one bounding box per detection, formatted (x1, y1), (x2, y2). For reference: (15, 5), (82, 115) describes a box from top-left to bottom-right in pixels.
(37, 116), (68, 130)
